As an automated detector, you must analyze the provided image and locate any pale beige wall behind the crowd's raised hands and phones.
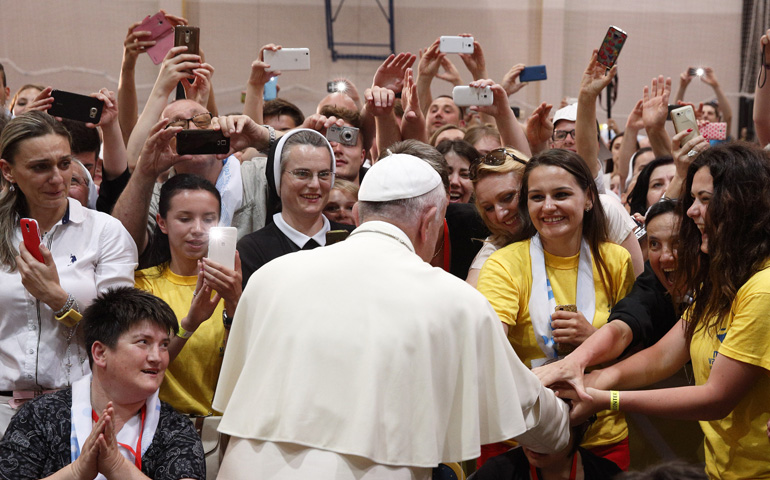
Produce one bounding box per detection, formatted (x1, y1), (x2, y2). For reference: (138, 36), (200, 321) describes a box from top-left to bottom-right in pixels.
(0, 0), (742, 127)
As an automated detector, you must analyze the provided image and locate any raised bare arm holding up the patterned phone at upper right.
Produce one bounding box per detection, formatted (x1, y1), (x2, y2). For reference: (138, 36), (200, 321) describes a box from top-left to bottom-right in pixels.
(575, 50), (618, 178)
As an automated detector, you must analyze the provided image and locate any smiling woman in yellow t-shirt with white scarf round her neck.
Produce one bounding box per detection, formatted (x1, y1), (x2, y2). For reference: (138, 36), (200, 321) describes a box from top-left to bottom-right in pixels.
(478, 149), (634, 469)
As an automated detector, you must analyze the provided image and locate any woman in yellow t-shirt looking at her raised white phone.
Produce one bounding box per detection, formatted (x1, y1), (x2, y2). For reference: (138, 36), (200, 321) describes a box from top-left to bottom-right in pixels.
(136, 174), (241, 415)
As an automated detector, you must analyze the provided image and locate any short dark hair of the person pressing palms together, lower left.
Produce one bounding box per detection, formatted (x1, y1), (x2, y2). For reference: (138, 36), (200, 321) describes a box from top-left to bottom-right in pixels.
(80, 287), (179, 366)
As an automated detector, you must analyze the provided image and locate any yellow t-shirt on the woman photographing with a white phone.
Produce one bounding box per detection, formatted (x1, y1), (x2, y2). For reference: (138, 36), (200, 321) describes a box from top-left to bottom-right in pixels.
(136, 267), (225, 415)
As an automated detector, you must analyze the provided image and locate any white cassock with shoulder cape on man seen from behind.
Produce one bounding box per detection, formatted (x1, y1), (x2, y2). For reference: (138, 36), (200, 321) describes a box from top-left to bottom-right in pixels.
(214, 221), (569, 479)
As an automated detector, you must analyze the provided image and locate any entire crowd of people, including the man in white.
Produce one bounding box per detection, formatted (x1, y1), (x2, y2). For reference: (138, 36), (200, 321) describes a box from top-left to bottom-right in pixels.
(0, 12), (770, 480)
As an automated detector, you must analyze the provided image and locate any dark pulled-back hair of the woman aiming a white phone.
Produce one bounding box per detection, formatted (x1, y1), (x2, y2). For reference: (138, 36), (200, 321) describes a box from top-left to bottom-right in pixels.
(143, 173), (222, 275)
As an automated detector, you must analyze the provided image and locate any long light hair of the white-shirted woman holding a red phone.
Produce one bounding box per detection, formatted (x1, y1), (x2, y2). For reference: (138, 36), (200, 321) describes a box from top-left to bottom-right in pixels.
(0, 111), (70, 272)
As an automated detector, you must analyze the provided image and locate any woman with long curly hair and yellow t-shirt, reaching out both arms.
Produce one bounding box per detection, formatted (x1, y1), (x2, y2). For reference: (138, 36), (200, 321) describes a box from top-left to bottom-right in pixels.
(574, 144), (770, 479)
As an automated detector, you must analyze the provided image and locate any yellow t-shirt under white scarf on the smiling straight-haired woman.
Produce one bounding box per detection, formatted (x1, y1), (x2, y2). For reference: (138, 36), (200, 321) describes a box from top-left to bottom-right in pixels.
(478, 240), (634, 448)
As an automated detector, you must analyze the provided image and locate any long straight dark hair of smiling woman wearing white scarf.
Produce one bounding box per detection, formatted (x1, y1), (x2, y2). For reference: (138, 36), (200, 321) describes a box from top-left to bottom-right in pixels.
(514, 148), (617, 302)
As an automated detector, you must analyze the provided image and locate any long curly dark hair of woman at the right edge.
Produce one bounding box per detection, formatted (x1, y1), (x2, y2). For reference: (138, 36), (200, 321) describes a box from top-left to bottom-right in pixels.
(676, 143), (770, 339)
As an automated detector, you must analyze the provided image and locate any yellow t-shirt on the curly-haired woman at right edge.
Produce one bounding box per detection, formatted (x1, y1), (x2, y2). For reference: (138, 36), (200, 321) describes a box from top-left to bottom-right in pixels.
(690, 262), (770, 480)
